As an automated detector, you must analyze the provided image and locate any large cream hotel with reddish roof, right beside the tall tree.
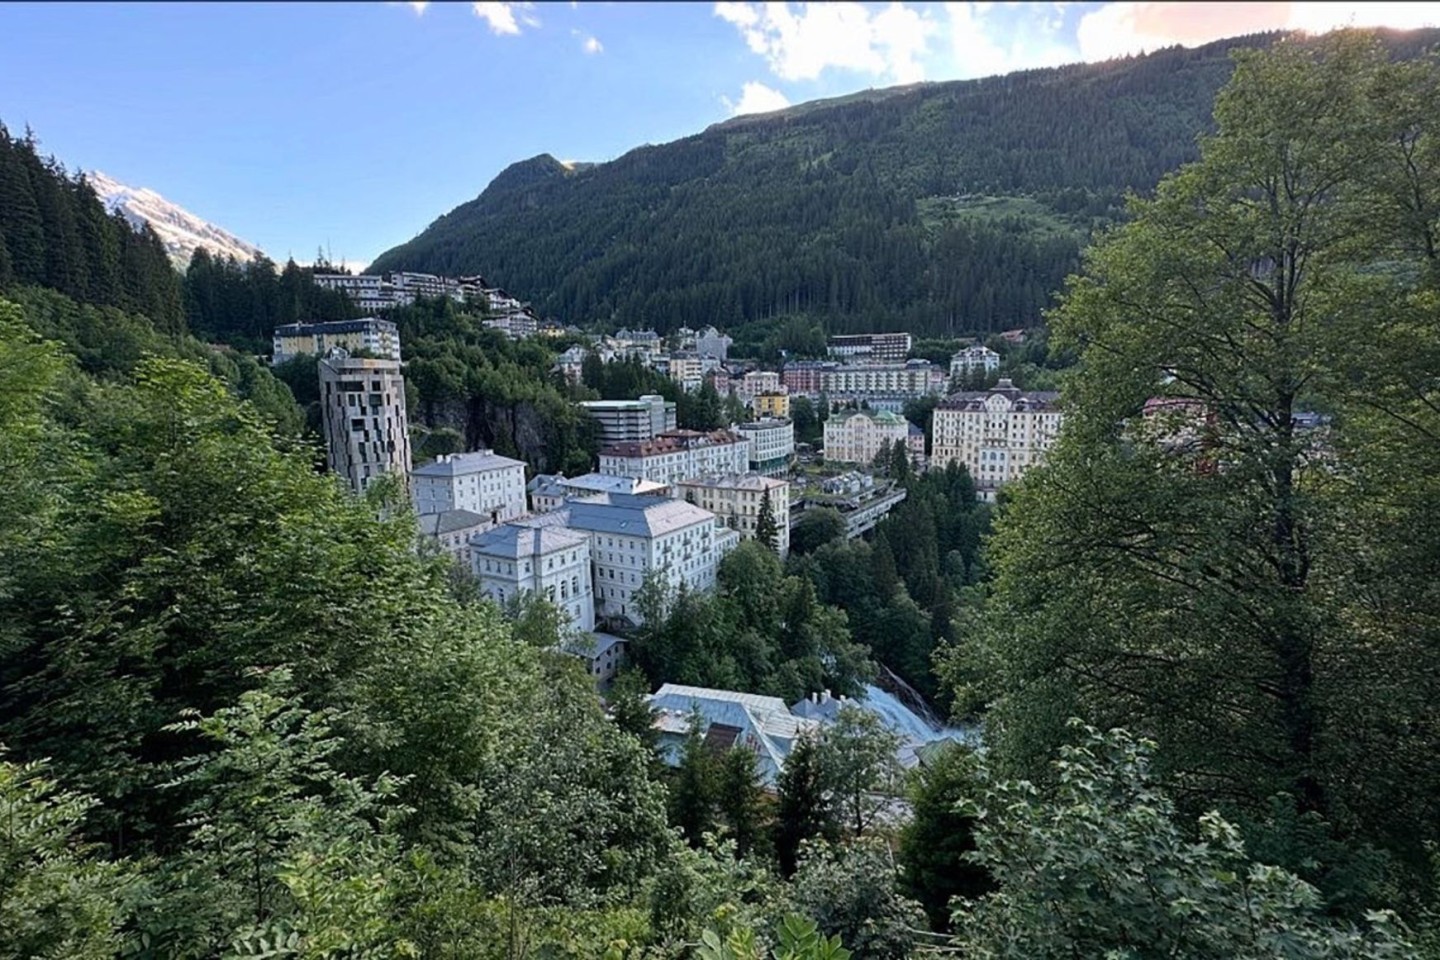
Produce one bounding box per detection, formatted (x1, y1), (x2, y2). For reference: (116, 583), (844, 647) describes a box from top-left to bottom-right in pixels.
(930, 379), (1061, 499)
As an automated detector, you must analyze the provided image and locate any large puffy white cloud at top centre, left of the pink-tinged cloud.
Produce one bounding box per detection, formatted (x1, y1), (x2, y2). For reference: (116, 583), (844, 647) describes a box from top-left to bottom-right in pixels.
(714, 1), (937, 83)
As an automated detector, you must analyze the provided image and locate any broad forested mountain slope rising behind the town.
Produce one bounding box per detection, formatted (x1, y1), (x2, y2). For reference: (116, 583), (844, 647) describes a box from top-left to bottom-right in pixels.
(373, 32), (1437, 335)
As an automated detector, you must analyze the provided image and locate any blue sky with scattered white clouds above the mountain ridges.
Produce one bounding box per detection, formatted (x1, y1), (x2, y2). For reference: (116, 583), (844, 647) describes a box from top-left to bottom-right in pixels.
(0, 3), (1440, 265)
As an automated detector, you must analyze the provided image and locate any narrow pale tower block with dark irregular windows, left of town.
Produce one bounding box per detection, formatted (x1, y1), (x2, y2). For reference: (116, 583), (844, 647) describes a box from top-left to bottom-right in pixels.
(320, 350), (410, 494)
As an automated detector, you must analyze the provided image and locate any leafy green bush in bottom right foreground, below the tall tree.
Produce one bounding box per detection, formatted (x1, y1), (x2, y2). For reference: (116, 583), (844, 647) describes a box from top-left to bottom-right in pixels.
(955, 728), (1414, 960)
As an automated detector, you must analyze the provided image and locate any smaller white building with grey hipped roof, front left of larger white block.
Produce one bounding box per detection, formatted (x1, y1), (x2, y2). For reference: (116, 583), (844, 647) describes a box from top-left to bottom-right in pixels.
(469, 524), (595, 630)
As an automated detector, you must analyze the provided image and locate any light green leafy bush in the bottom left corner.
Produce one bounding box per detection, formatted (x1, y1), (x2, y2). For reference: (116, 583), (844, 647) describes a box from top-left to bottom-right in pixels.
(0, 759), (138, 960)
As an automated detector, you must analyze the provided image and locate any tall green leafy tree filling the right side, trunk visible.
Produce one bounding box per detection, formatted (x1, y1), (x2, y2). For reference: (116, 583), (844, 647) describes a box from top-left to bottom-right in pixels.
(967, 24), (1440, 915)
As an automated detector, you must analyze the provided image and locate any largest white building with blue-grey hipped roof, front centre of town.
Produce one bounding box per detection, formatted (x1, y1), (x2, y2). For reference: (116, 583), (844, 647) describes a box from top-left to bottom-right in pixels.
(561, 494), (740, 623)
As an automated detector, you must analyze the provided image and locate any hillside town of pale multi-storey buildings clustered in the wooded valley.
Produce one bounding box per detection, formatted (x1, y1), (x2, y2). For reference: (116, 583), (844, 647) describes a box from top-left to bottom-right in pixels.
(283, 272), (1061, 770)
